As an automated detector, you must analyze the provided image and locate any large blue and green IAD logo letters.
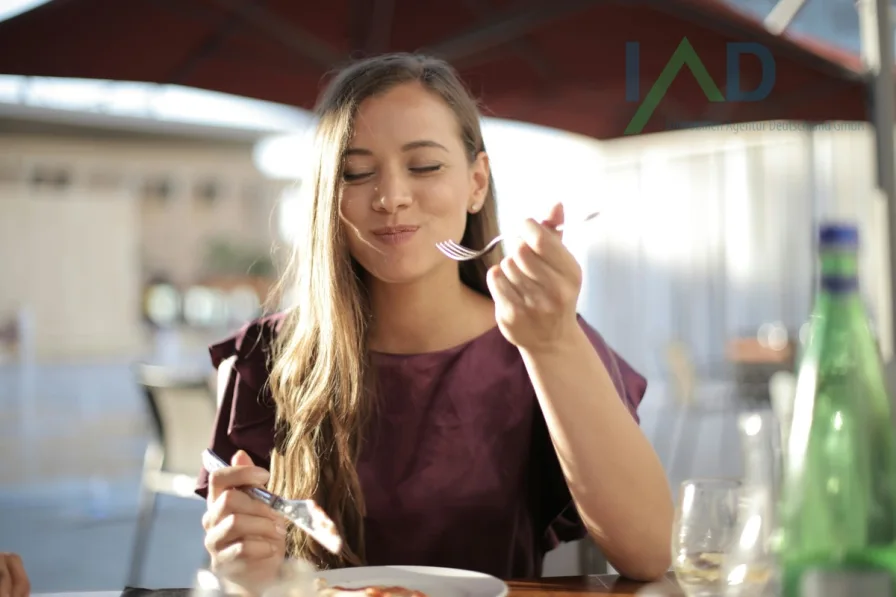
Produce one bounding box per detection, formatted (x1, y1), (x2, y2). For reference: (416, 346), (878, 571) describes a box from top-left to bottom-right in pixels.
(625, 37), (775, 135)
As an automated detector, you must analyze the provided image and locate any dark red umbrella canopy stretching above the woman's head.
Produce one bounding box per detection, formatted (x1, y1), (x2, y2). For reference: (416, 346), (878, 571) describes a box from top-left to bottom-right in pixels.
(0, 0), (867, 139)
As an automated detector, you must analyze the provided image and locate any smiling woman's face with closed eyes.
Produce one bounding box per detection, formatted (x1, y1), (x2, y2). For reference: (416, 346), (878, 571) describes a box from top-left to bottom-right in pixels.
(340, 83), (489, 283)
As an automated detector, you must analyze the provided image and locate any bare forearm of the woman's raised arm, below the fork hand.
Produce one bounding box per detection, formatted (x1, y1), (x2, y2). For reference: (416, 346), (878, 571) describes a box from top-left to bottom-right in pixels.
(521, 329), (673, 579)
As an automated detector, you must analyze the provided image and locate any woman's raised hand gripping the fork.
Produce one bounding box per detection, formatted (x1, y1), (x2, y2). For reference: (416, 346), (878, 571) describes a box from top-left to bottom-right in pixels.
(488, 203), (582, 351)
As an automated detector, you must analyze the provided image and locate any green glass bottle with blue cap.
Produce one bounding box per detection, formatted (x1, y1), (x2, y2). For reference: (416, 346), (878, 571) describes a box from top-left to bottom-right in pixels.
(779, 224), (896, 597)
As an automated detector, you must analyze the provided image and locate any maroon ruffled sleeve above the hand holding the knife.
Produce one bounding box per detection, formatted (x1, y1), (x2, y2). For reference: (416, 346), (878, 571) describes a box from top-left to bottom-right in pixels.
(196, 313), (284, 497)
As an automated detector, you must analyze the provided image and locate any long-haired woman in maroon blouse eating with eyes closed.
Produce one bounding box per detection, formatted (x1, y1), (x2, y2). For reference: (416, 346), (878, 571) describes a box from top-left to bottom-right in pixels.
(197, 54), (672, 579)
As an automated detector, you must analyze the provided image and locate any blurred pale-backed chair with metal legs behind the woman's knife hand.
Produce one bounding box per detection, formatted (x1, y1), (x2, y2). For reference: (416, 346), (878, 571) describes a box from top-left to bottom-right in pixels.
(127, 364), (216, 587)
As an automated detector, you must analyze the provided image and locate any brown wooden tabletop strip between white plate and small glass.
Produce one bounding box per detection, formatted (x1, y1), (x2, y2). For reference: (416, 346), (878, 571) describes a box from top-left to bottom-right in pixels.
(507, 573), (683, 597)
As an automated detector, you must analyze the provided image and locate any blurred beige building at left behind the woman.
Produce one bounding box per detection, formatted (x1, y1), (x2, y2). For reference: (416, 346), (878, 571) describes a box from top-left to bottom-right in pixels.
(0, 107), (284, 358)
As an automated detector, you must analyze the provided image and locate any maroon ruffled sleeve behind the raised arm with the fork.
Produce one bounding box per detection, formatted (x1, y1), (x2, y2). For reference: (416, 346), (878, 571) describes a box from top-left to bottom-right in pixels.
(532, 316), (647, 552)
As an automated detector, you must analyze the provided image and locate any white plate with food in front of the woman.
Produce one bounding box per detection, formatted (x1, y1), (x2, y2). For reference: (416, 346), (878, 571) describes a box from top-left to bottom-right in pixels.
(317, 566), (508, 597)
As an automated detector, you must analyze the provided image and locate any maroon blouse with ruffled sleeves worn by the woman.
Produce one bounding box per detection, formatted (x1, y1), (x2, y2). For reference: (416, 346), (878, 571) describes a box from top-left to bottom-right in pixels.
(196, 314), (647, 578)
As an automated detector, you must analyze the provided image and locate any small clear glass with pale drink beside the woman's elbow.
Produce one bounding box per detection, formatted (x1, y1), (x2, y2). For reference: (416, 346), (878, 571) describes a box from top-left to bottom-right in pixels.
(672, 479), (740, 597)
